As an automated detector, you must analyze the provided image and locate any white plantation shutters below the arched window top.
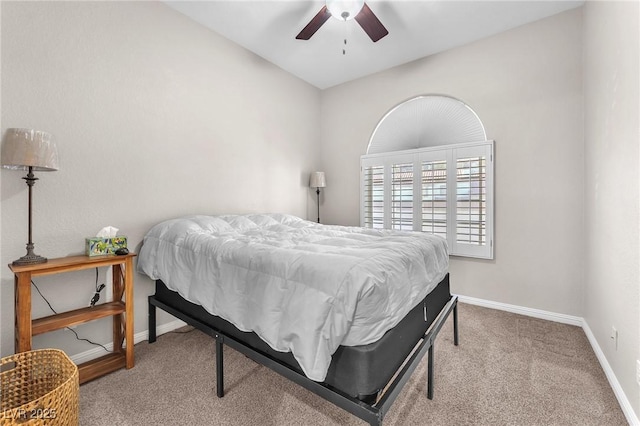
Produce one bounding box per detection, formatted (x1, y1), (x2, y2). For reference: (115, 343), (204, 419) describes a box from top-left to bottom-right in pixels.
(361, 141), (493, 259)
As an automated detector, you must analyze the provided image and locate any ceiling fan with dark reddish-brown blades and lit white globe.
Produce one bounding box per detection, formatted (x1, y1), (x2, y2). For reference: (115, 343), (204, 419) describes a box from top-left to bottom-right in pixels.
(296, 0), (389, 42)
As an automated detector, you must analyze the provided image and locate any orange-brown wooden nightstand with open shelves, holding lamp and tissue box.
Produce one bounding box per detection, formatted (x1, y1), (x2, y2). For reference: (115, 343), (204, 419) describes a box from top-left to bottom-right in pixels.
(9, 253), (135, 383)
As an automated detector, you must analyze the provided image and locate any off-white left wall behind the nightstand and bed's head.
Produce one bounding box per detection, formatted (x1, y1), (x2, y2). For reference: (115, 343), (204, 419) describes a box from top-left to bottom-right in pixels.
(0, 2), (320, 355)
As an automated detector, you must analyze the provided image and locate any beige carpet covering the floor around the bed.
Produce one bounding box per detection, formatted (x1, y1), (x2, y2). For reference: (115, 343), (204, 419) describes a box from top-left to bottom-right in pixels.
(80, 304), (627, 426)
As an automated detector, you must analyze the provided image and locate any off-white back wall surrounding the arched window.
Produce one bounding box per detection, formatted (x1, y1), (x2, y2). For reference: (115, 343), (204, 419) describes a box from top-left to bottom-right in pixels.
(321, 9), (585, 316)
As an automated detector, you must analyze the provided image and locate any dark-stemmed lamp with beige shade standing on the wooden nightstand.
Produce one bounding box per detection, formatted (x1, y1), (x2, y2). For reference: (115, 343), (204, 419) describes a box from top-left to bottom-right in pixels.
(2, 129), (58, 265)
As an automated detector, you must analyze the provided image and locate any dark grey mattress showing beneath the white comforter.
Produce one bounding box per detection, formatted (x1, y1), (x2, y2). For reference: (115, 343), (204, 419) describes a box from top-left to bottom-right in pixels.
(155, 274), (451, 403)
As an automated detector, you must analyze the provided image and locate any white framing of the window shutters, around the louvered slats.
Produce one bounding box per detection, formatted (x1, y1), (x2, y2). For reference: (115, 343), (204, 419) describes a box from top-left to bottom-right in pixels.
(360, 140), (494, 259)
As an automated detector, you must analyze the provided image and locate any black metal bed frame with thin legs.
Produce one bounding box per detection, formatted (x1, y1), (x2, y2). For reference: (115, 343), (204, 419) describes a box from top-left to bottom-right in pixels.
(149, 286), (458, 425)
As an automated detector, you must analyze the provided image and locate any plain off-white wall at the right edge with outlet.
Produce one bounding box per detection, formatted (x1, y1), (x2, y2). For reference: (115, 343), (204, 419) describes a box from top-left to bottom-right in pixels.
(583, 2), (640, 418)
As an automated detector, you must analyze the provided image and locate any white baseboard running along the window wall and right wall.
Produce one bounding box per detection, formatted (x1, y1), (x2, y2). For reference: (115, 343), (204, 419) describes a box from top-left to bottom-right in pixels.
(458, 296), (640, 426)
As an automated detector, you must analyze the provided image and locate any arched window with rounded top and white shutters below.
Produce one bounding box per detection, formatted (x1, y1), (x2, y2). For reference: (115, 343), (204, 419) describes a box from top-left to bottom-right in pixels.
(360, 95), (493, 259)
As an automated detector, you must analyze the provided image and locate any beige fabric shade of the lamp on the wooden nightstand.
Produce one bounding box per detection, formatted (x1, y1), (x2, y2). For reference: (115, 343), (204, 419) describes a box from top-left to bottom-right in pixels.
(2, 129), (58, 172)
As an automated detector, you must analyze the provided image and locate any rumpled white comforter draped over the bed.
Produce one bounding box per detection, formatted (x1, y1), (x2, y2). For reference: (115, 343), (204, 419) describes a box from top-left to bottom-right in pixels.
(138, 214), (449, 381)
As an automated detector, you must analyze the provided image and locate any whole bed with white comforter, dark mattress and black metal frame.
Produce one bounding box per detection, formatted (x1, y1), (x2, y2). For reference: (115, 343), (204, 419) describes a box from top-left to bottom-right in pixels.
(138, 214), (458, 424)
